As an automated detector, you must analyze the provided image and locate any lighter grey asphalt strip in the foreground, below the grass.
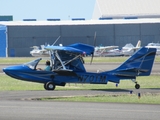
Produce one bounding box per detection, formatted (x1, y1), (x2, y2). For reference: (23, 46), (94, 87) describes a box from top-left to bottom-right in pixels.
(0, 101), (160, 120)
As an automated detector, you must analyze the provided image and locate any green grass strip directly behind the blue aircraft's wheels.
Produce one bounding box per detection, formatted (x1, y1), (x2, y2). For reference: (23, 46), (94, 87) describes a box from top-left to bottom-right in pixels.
(0, 74), (160, 91)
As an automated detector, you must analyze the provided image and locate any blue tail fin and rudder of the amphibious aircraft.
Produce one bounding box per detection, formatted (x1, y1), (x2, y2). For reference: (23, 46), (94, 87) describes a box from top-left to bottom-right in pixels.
(115, 47), (156, 76)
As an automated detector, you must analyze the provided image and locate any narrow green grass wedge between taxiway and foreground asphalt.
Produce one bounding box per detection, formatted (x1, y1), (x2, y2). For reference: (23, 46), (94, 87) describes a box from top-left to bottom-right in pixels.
(40, 93), (160, 104)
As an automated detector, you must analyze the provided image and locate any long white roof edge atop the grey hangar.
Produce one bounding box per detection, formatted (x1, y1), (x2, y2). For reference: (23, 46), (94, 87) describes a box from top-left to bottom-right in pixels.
(0, 18), (160, 26)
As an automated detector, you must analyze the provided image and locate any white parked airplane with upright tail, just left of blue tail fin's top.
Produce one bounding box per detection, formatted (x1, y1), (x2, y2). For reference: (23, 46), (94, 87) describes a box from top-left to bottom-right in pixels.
(121, 40), (141, 56)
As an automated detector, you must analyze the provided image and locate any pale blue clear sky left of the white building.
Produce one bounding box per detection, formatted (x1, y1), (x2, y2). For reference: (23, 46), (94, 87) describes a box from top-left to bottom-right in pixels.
(0, 0), (96, 21)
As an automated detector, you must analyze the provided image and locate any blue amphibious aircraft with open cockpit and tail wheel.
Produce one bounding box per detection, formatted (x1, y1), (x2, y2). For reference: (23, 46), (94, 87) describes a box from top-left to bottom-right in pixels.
(3, 43), (156, 90)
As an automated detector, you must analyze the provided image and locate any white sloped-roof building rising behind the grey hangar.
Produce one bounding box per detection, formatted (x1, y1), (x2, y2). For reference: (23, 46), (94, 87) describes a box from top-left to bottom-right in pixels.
(93, 0), (160, 19)
